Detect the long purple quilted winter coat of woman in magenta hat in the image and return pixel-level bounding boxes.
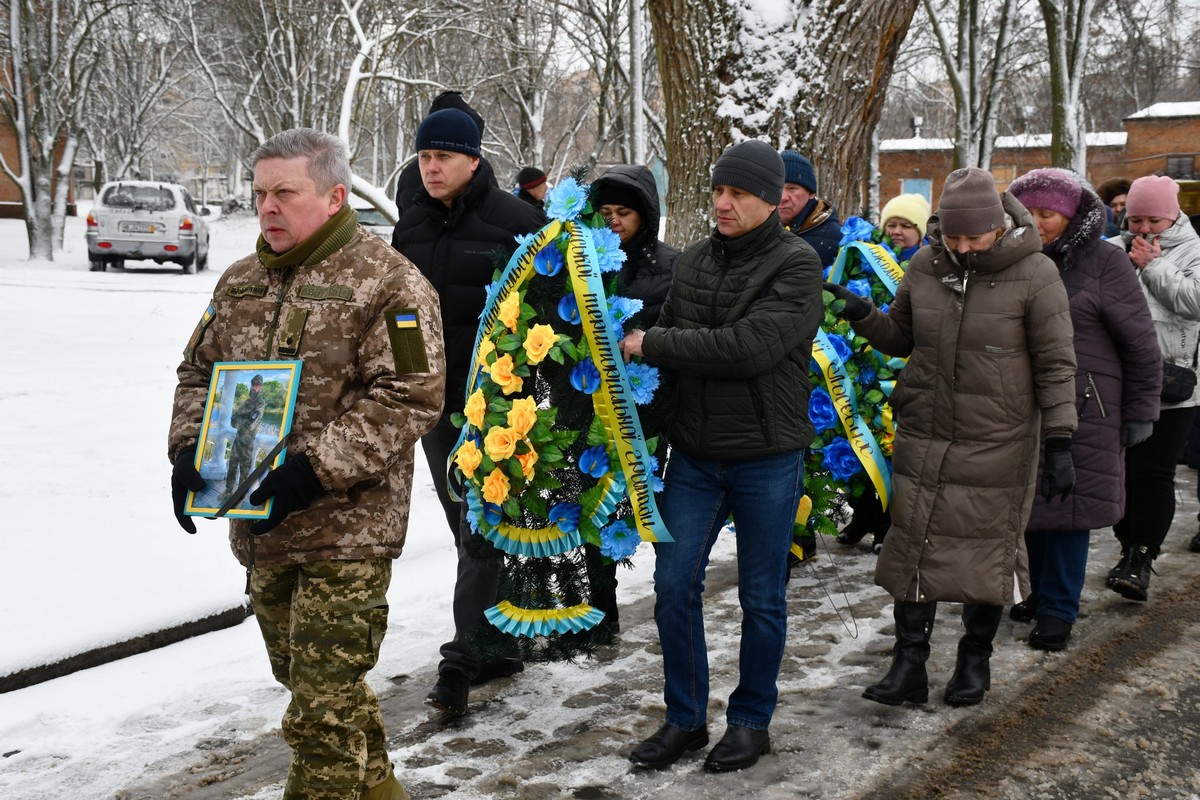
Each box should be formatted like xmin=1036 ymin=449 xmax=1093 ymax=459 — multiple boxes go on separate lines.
xmin=1028 ymin=183 xmax=1163 ymax=530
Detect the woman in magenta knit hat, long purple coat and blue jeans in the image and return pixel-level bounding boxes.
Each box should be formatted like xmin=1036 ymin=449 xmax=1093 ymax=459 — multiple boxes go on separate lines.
xmin=1008 ymin=169 xmax=1163 ymax=650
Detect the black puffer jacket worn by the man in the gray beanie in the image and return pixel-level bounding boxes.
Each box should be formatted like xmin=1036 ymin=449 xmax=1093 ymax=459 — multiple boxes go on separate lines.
xmin=642 ymin=211 xmax=822 ymax=461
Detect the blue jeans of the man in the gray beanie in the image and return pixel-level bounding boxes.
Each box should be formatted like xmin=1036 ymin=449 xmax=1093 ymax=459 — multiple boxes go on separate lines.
xmin=654 ymin=450 xmax=804 ymax=730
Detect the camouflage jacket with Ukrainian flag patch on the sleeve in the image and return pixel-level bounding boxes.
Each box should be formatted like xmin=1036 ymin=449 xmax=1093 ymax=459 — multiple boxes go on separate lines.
xmin=167 ymin=227 xmax=445 ymax=567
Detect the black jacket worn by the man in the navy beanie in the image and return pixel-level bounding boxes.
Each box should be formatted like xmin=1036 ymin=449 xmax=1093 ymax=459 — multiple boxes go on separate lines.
xmin=391 ymin=160 xmax=546 ymax=414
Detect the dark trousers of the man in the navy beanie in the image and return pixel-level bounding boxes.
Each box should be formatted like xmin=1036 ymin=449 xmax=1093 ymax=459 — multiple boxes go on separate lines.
xmin=421 ymin=415 xmax=504 ymax=678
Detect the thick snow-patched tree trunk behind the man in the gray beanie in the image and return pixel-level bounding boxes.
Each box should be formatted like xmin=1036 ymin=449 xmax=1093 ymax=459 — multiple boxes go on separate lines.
xmin=648 ymin=0 xmax=917 ymax=242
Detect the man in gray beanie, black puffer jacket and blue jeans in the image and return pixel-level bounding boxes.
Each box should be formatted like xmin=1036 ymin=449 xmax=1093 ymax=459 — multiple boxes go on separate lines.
xmin=620 ymin=142 xmax=822 ymax=772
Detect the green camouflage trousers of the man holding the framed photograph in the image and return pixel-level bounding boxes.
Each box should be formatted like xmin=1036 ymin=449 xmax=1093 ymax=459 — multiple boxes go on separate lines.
xmin=250 ymin=559 xmax=391 ymax=800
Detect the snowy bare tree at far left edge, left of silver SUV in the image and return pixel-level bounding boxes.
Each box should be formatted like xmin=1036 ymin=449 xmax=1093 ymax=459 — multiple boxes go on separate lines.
xmin=0 ymin=0 xmax=110 ymax=260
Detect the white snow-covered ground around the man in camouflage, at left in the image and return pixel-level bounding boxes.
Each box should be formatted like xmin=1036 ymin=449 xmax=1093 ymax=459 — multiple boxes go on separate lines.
xmin=0 ymin=207 xmax=650 ymax=800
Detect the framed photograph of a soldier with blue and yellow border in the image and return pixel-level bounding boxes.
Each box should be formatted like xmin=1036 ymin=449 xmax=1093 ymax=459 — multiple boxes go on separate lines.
xmin=184 ymin=361 xmax=301 ymax=519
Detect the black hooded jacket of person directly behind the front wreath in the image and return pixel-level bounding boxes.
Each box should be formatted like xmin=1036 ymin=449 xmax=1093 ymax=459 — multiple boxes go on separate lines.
xmin=592 ymin=164 xmax=679 ymax=330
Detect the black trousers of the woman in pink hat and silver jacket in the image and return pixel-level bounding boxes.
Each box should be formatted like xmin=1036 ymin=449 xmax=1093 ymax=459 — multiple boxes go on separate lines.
xmin=1112 ymin=408 xmax=1196 ymax=558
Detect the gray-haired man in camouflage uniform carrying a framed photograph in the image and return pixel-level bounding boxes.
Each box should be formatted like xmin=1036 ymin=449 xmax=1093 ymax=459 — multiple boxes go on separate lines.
xmin=168 ymin=128 xmax=444 ymax=800
